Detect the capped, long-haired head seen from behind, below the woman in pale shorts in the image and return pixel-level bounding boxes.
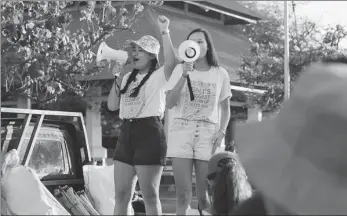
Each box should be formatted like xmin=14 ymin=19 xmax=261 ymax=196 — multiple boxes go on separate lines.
xmin=207 ymin=152 xmax=252 ymax=215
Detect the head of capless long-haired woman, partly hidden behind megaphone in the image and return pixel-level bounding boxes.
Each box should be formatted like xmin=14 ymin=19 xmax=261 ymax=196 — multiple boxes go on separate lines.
xmin=187 ymin=28 xmax=219 ymax=67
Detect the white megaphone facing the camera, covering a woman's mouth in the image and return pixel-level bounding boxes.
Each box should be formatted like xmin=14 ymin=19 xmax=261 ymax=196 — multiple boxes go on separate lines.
xmin=178 ymin=40 xmax=200 ymax=62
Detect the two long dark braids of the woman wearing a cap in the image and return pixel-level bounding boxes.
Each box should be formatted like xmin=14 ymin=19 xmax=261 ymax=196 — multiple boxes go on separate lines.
xmin=120 ymin=58 xmax=158 ymax=97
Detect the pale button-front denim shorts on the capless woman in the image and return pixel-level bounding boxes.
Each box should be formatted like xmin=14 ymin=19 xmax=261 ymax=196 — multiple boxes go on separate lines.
xmin=167 ymin=118 xmax=219 ymax=161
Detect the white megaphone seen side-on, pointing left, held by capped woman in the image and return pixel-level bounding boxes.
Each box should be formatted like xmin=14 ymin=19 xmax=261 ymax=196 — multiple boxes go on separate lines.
xmin=96 ymin=42 xmax=128 ymax=64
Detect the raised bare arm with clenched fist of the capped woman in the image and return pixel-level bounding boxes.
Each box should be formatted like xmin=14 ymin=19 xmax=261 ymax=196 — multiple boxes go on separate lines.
xmin=158 ymin=15 xmax=179 ymax=80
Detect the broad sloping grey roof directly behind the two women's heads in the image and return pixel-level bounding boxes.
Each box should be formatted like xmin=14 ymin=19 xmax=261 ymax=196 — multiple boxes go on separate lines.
xmin=79 ymin=10 xmax=250 ymax=81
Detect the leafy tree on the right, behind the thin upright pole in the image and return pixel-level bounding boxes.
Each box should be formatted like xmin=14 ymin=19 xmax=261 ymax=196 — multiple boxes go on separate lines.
xmin=237 ymin=2 xmax=347 ymax=111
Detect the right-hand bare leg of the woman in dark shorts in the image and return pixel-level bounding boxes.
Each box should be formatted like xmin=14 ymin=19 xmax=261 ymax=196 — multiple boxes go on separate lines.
xmin=135 ymin=165 xmax=164 ymax=215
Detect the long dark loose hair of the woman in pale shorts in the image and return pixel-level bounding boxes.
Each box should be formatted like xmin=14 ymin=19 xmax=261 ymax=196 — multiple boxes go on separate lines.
xmin=187 ymin=28 xmax=220 ymax=67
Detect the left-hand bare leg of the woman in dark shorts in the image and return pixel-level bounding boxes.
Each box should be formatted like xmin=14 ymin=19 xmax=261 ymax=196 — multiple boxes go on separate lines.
xmin=114 ymin=160 xmax=137 ymax=215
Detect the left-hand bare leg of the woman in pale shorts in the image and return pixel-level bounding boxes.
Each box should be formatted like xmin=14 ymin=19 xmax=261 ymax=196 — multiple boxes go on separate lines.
xmin=172 ymin=158 xmax=193 ymax=215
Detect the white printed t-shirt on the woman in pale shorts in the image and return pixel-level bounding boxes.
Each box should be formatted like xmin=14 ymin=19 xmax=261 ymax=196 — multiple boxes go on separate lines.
xmin=165 ymin=64 xmax=231 ymax=124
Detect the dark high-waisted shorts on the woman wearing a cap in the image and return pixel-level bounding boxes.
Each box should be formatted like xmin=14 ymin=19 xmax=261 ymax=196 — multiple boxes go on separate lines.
xmin=113 ymin=117 xmax=167 ymax=166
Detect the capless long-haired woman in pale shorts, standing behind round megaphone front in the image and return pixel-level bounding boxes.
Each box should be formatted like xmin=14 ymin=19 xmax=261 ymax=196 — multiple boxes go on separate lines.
xmin=165 ymin=28 xmax=231 ymax=215
